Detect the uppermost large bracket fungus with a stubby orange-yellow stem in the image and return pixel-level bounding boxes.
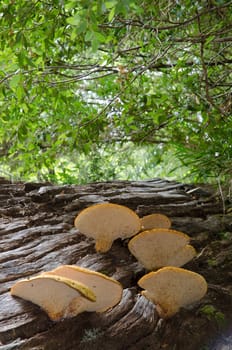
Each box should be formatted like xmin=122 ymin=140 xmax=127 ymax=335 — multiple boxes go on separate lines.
xmin=74 ymin=203 xmax=141 ymax=253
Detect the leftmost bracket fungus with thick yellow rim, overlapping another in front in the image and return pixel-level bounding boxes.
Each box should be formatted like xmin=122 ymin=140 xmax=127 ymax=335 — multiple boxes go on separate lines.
xmin=11 ymin=273 xmax=96 ymax=321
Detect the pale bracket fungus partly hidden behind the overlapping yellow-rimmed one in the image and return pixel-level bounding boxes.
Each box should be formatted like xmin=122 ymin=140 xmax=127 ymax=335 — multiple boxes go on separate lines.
xmin=44 ymin=265 xmax=123 ymax=312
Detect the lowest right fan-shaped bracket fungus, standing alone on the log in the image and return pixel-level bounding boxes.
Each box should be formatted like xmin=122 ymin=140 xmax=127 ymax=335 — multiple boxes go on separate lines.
xmin=138 ymin=266 xmax=207 ymax=318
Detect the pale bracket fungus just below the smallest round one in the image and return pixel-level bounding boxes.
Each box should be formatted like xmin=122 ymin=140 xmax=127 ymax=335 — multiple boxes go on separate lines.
xmin=128 ymin=229 xmax=196 ymax=270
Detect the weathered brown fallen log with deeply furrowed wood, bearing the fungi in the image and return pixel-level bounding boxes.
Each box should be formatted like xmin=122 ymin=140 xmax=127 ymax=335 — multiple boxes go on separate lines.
xmin=0 ymin=179 xmax=232 ymax=350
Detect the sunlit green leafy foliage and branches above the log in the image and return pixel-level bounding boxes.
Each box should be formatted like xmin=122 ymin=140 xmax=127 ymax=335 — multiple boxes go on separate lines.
xmin=0 ymin=0 xmax=232 ymax=182
